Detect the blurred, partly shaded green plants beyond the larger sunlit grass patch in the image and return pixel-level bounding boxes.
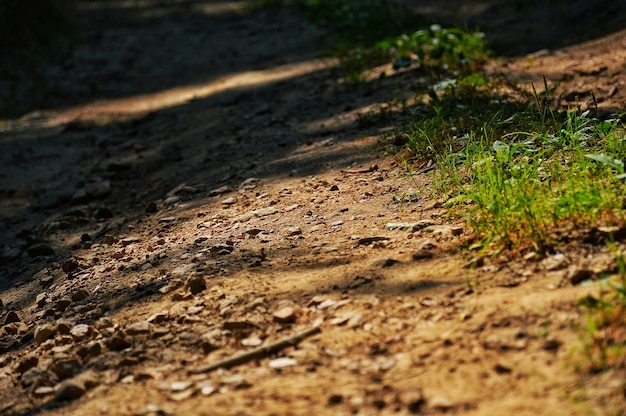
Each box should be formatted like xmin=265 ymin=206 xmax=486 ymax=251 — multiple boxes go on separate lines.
xmin=259 ymin=0 xmax=489 ymax=83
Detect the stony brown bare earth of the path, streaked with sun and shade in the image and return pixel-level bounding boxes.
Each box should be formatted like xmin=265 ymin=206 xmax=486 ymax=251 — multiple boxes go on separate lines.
xmin=0 ymin=0 xmax=626 ymax=415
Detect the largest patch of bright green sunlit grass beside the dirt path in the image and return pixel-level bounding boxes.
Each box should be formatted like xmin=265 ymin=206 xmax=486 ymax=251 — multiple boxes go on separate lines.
xmin=407 ymin=79 xmax=626 ymax=252
